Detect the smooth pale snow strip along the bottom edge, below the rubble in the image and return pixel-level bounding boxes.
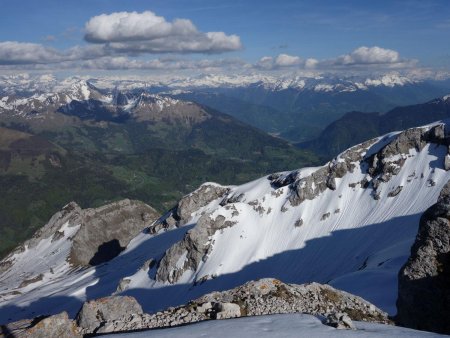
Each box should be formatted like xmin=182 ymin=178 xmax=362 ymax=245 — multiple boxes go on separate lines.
xmin=105 ymin=314 xmax=445 ymax=338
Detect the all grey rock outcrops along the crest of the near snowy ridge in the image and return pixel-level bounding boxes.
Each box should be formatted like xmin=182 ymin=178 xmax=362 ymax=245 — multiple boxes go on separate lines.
xmin=156 ymin=124 xmax=450 ymax=283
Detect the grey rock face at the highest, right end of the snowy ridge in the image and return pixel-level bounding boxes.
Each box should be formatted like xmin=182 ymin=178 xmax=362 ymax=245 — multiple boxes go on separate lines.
xmin=284 ymin=125 xmax=450 ymax=206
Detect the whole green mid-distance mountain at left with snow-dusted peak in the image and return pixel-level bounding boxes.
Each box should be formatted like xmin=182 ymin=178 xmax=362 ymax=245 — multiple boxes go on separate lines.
xmin=0 ymin=81 xmax=317 ymax=254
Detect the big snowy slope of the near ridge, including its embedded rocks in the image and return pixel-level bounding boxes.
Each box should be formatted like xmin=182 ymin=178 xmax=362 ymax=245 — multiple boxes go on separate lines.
xmin=0 ymin=124 xmax=450 ymax=322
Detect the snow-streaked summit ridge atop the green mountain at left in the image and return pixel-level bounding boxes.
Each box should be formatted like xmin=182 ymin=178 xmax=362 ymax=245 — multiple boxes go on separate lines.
xmin=0 ymin=80 xmax=210 ymax=125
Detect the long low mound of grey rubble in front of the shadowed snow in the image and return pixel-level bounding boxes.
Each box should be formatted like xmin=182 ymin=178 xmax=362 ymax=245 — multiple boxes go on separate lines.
xmin=78 ymin=279 xmax=389 ymax=333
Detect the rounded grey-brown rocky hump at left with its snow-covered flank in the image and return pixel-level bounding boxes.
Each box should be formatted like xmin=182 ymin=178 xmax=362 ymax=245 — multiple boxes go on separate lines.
xmin=0 ymin=199 xmax=158 ymax=288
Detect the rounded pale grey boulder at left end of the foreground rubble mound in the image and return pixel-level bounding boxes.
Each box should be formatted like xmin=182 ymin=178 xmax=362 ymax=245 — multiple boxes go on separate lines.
xmin=76 ymin=296 xmax=143 ymax=333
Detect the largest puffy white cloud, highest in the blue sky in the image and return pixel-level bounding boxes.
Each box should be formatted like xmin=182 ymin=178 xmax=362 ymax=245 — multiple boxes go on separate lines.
xmin=85 ymin=11 xmax=242 ymax=53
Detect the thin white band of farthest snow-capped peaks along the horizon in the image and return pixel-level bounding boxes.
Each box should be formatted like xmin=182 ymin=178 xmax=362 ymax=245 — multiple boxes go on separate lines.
xmin=0 ymin=72 xmax=419 ymax=95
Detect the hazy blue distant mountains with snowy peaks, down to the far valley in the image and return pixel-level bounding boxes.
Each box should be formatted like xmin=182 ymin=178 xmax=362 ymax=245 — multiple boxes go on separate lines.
xmin=0 ymin=73 xmax=450 ymax=142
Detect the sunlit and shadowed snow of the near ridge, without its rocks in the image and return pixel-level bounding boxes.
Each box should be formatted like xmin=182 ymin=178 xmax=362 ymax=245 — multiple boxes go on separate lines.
xmin=0 ymin=121 xmax=450 ymax=330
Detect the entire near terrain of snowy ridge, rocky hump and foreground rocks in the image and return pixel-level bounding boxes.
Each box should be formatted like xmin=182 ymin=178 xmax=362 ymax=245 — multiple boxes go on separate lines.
xmin=0 ymin=121 xmax=450 ymax=336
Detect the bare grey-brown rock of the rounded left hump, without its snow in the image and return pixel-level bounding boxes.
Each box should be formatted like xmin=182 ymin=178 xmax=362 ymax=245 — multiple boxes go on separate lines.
xmin=0 ymin=199 xmax=159 ymax=274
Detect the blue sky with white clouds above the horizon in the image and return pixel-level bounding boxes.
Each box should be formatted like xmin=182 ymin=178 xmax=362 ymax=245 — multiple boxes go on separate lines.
xmin=0 ymin=0 xmax=450 ymax=75
